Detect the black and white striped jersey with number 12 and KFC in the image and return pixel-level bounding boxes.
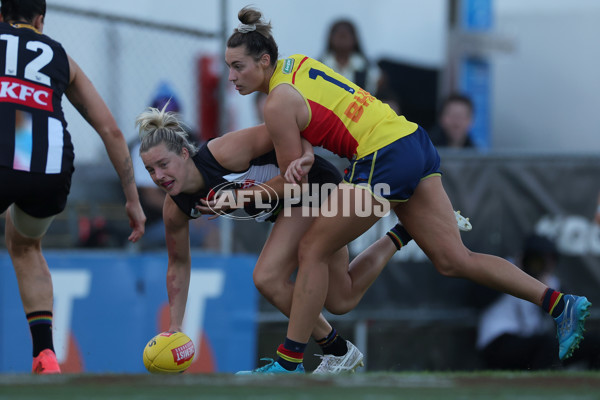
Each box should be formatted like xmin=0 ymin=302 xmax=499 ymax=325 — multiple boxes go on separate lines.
xmin=0 ymin=23 xmax=74 ymax=174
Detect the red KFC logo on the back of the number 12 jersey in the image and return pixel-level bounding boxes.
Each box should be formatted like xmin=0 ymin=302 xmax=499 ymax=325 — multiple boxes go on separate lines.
xmin=0 ymin=77 xmax=54 ymax=111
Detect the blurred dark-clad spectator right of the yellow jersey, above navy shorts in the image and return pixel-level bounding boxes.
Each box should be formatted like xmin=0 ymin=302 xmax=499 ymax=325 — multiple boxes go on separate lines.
xmin=429 ymin=94 xmax=475 ymax=149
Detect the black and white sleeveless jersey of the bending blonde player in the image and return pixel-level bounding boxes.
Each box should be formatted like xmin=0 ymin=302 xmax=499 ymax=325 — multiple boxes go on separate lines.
xmin=171 ymin=143 xmax=342 ymax=221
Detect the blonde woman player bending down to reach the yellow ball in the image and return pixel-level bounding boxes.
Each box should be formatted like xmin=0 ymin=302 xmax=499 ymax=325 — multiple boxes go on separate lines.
xmin=137 ymin=108 xmax=469 ymax=373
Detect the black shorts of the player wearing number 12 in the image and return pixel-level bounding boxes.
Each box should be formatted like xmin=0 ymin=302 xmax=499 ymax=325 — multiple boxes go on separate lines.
xmin=0 ymin=167 xmax=72 ymax=218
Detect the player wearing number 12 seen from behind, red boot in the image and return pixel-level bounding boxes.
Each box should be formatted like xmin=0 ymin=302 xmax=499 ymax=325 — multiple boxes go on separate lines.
xmin=0 ymin=0 xmax=146 ymax=374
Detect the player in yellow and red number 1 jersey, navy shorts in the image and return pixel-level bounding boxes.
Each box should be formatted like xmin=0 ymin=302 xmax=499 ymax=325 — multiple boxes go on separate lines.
xmin=225 ymin=7 xmax=591 ymax=373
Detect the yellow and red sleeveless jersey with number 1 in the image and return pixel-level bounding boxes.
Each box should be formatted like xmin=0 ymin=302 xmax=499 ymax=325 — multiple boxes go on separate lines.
xmin=269 ymin=54 xmax=418 ymax=159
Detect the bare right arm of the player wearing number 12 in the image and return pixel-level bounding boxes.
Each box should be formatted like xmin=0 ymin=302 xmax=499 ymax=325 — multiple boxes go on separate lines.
xmin=65 ymin=57 xmax=146 ymax=242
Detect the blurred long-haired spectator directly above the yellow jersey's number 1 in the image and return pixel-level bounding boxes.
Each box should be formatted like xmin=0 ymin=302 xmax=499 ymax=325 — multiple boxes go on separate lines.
xmin=319 ymin=19 xmax=380 ymax=93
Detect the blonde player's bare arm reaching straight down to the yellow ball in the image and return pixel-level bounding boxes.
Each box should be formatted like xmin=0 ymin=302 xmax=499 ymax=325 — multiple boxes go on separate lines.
xmin=163 ymin=195 xmax=192 ymax=331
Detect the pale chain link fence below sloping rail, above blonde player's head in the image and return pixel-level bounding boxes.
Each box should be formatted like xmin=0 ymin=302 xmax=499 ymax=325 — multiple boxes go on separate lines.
xmin=44 ymin=4 xmax=221 ymax=165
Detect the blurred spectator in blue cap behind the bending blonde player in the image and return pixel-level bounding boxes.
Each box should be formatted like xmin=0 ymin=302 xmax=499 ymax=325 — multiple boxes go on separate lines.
xmin=130 ymin=82 xmax=219 ymax=250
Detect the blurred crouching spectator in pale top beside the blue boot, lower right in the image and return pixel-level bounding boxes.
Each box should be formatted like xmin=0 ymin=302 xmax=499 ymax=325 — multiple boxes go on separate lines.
xmin=477 ymin=235 xmax=600 ymax=370
